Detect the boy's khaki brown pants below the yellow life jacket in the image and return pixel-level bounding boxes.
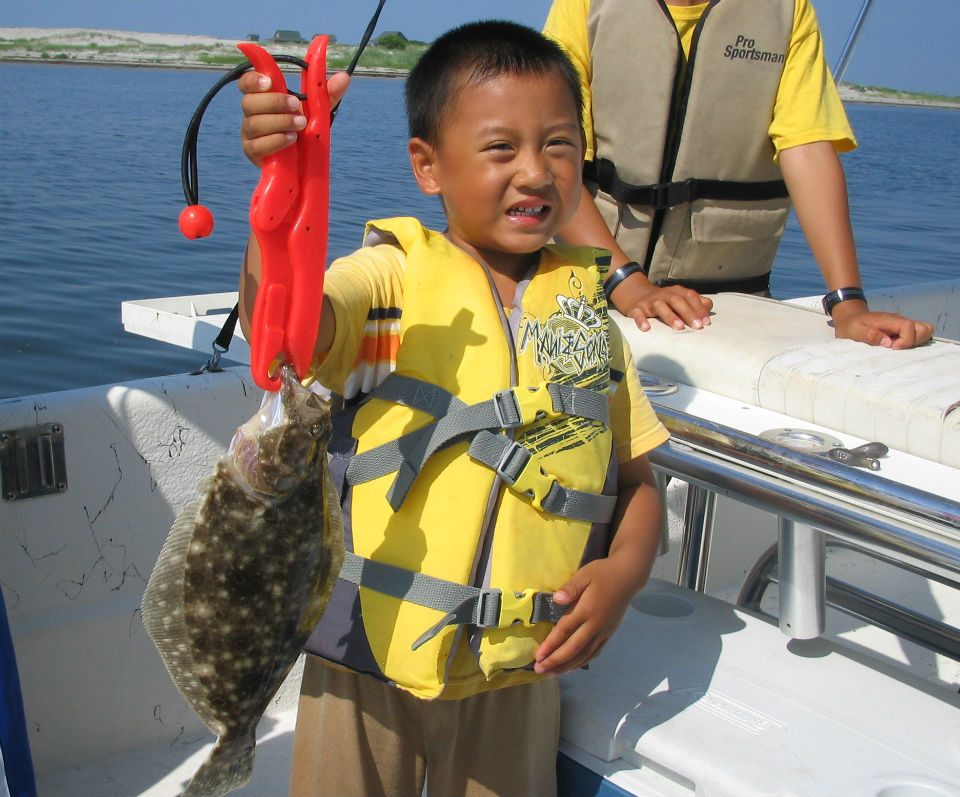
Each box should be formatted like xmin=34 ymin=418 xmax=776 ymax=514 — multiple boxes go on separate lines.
xmin=290 ymin=656 xmax=560 ymax=797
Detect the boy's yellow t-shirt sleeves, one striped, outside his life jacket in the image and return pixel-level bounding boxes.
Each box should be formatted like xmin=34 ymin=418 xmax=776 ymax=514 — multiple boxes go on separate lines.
xmin=311 ymin=236 xmax=669 ymax=462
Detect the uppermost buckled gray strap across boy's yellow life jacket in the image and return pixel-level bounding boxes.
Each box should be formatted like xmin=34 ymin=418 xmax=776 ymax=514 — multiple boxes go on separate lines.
xmin=347 ymin=377 xmax=610 ymax=511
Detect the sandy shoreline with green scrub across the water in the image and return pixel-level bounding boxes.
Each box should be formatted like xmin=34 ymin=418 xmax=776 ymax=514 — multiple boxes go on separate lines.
xmin=0 ymin=27 xmax=960 ymax=110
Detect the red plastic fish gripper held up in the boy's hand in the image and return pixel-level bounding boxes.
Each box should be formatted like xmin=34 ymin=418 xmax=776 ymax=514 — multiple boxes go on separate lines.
xmin=237 ymin=36 xmax=330 ymax=390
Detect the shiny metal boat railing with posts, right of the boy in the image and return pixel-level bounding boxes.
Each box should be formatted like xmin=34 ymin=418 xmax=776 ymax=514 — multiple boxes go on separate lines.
xmin=650 ymin=405 xmax=960 ymax=660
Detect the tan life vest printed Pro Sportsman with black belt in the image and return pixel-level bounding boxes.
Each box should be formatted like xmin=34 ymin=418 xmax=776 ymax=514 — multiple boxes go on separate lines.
xmin=586 ymin=0 xmax=794 ymax=292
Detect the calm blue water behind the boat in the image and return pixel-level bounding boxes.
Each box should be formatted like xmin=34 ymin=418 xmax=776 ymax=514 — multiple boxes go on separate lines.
xmin=0 ymin=64 xmax=960 ymax=398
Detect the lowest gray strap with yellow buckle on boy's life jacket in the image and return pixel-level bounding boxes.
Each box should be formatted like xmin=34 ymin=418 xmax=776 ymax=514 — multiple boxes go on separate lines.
xmin=340 ymin=551 xmax=568 ymax=650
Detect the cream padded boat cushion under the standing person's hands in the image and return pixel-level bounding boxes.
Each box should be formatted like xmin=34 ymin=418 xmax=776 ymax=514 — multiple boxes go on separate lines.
xmin=612 ymin=293 xmax=960 ymax=467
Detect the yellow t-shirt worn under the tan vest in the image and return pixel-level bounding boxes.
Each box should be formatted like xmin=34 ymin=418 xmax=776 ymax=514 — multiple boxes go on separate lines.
xmin=544 ymin=0 xmax=857 ymax=160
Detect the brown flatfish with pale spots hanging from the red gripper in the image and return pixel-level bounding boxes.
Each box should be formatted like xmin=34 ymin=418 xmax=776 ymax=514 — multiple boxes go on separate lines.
xmin=142 ymin=366 xmax=343 ymax=797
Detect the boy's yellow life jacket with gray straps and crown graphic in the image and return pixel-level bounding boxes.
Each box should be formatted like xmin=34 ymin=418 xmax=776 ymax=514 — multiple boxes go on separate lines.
xmin=307 ymin=218 xmax=616 ymax=698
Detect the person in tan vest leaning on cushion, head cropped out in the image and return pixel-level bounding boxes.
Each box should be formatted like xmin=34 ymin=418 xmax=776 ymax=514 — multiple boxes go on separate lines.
xmin=544 ymin=0 xmax=933 ymax=348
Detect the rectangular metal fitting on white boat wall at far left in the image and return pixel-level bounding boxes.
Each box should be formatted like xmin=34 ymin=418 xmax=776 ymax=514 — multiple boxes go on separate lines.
xmin=0 ymin=423 xmax=67 ymax=501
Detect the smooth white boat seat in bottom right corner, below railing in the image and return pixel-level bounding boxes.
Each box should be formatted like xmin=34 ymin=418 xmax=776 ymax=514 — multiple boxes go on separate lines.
xmin=560 ymin=579 xmax=960 ymax=797
